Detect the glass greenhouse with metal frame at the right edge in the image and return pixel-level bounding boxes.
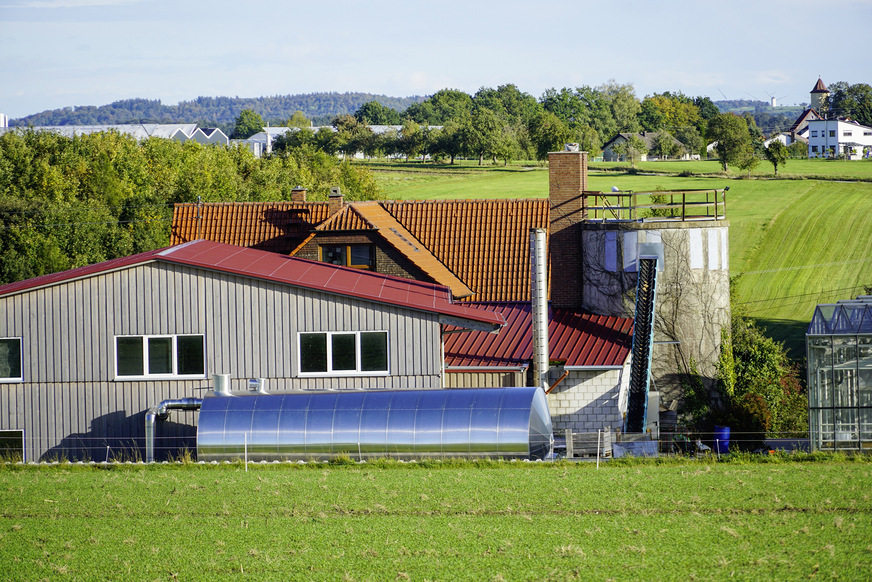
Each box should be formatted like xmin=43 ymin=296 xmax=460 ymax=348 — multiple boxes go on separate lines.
xmin=806 ymin=296 xmax=872 ymax=452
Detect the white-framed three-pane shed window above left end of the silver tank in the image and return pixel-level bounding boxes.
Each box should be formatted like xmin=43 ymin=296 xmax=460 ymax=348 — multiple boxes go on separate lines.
xmin=115 ymin=335 xmax=206 ymax=378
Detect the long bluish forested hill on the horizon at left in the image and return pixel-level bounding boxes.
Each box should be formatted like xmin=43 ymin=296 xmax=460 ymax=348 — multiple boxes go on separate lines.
xmin=9 ymin=93 xmax=425 ymax=128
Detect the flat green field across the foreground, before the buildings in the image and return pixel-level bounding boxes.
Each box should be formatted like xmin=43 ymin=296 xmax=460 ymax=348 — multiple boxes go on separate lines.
xmin=0 ymin=456 xmax=872 ymax=582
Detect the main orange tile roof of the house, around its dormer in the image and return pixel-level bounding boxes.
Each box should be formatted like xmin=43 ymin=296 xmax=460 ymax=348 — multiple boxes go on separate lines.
xmin=172 ymin=198 xmax=549 ymax=301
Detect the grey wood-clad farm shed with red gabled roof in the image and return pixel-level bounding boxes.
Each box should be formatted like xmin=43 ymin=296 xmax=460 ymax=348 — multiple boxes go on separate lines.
xmin=0 ymin=240 xmax=504 ymax=460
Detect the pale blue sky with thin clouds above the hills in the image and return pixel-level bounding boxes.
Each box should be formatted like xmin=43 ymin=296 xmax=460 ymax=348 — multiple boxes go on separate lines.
xmin=0 ymin=0 xmax=872 ymax=119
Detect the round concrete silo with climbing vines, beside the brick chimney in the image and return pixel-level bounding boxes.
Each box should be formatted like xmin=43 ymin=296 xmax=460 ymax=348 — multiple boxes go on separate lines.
xmin=581 ymin=219 xmax=730 ymax=402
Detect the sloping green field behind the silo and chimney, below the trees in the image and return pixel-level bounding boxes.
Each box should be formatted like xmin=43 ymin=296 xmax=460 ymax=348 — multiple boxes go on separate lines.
xmin=374 ymin=160 xmax=872 ymax=359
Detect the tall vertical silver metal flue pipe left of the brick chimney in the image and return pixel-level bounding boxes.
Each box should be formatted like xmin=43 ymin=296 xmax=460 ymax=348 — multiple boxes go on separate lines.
xmin=530 ymin=228 xmax=549 ymax=390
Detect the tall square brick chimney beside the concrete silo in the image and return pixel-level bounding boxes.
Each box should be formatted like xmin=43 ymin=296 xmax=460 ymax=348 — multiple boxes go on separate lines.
xmin=548 ymin=144 xmax=587 ymax=309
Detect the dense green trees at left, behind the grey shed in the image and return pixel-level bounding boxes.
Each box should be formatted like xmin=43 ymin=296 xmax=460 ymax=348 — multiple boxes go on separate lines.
xmin=0 ymin=130 xmax=379 ymax=284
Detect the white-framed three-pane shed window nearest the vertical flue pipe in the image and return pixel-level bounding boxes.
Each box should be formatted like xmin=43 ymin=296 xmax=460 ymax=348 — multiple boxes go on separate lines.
xmin=300 ymin=331 xmax=388 ymax=375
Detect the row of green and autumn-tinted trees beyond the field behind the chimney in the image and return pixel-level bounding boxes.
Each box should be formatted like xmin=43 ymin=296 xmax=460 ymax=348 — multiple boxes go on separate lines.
xmin=231 ymin=82 xmax=806 ymax=173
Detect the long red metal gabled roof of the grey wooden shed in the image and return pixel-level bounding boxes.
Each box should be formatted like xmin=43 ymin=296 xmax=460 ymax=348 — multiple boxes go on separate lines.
xmin=0 ymin=240 xmax=505 ymax=326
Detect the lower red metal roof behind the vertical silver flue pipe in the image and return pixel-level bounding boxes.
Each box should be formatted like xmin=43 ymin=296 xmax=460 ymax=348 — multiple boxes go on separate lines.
xmin=445 ymin=302 xmax=633 ymax=370
